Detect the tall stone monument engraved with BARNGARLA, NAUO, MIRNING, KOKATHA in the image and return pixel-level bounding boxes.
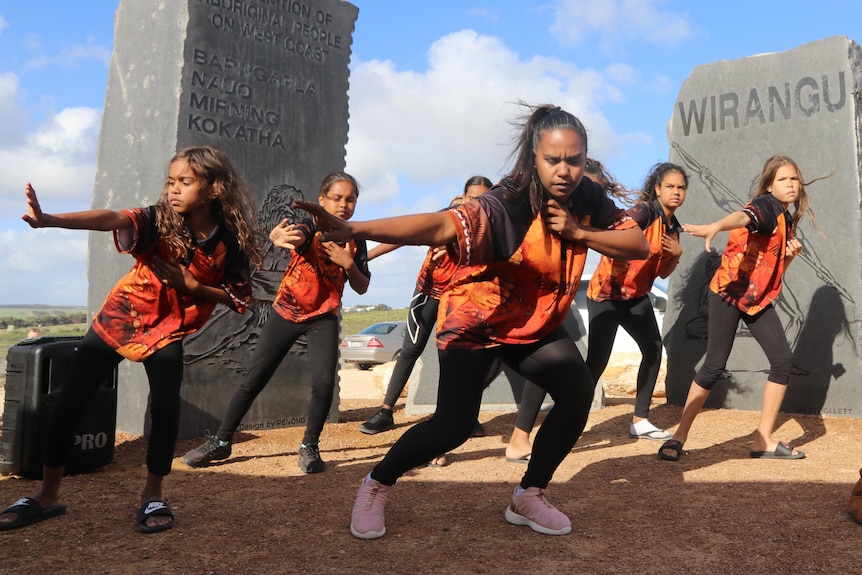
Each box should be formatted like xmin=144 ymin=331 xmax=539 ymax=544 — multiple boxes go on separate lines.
xmin=88 ymin=0 xmax=358 ymax=437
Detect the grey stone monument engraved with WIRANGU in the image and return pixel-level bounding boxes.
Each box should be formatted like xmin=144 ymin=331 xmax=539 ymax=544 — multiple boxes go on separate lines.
xmin=663 ymin=37 xmax=862 ymax=417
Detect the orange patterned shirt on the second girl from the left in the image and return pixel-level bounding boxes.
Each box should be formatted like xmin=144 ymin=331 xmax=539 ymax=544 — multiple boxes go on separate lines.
xmin=272 ymin=229 xmax=371 ymax=323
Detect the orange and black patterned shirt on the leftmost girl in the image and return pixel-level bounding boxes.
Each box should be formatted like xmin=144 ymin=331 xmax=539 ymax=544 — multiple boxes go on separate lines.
xmin=92 ymin=206 xmax=251 ymax=361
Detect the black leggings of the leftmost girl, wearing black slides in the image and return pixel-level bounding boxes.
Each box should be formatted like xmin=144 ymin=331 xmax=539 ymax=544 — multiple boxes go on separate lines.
xmin=44 ymin=329 xmax=183 ymax=476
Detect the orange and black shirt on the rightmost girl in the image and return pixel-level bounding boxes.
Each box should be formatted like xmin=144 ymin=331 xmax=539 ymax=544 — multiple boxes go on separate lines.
xmin=709 ymin=194 xmax=793 ymax=315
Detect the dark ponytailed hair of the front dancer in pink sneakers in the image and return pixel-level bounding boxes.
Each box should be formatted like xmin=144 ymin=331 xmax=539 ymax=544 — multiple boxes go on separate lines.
xmin=506 ymin=102 xmax=587 ymax=215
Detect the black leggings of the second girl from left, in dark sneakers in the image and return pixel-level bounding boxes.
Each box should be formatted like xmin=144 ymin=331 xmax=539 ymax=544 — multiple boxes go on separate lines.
xmin=216 ymin=312 xmax=338 ymax=444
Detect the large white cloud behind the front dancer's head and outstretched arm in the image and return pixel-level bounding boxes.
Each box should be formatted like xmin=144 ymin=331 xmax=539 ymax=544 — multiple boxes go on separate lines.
xmin=347 ymin=30 xmax=621 ymax=207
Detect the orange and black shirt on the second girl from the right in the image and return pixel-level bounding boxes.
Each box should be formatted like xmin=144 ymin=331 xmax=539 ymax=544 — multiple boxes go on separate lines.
xmin=587 ymin=200 xmax=680 ymax=301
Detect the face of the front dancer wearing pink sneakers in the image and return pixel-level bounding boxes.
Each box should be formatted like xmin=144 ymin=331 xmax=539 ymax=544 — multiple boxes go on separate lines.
xmin=534 ymin=128 xmax=587 ymax=205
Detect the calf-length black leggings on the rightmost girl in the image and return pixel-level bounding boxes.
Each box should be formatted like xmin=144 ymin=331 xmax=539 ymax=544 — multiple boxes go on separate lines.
xmin=694 ymin=291 xmax=793 ymax=389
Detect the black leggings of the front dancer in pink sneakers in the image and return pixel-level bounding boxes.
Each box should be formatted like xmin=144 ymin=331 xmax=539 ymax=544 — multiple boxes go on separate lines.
xmin=371 ymin=327 xmax=593 ymax=489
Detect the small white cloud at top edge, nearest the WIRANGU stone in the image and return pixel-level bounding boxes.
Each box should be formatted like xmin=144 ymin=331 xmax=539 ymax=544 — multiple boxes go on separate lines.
xmin=550 ymin=0 xmax=692 ymax=52
